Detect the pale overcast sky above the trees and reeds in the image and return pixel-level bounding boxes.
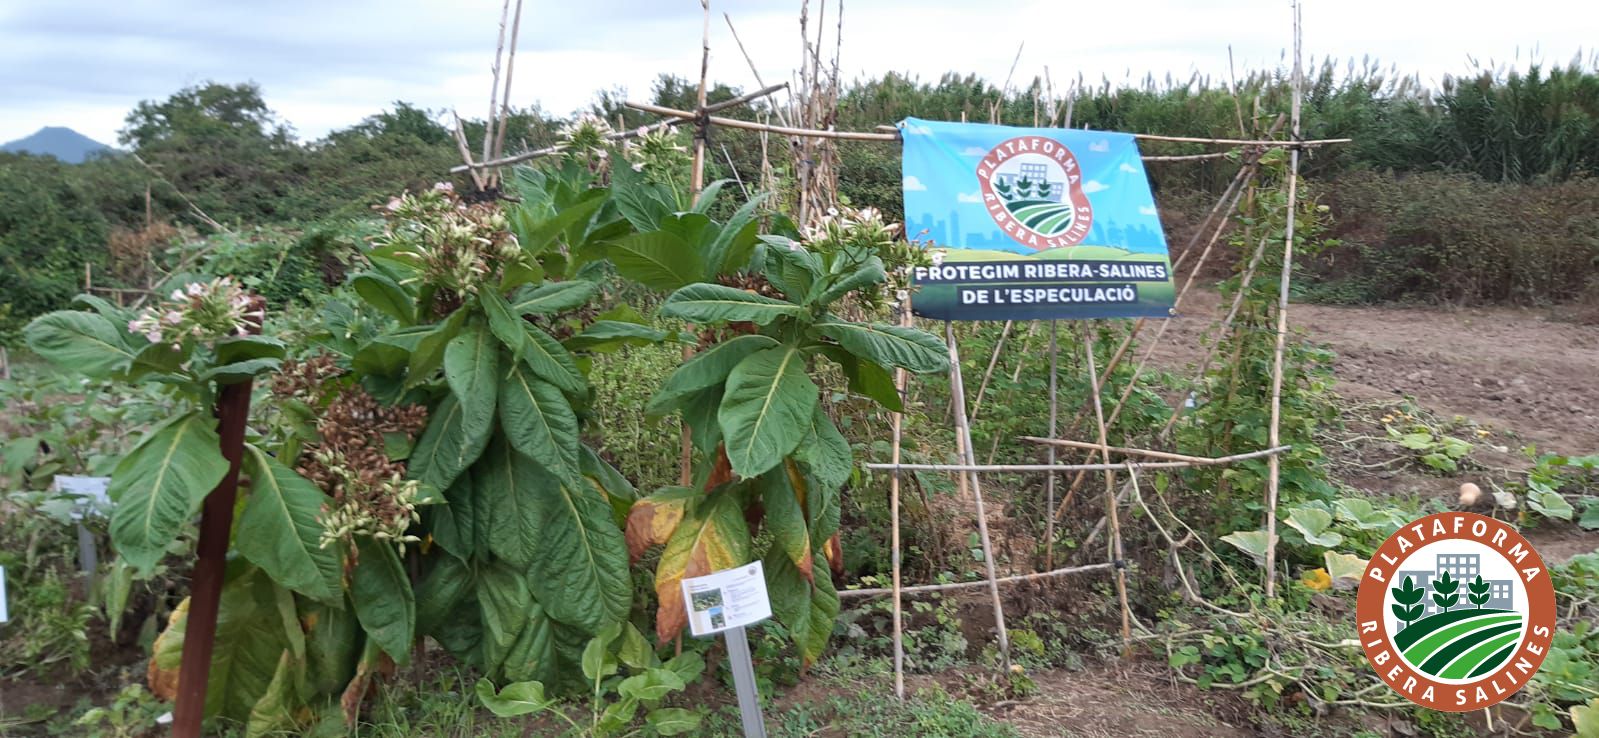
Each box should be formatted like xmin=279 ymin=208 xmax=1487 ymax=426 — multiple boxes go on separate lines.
xmin=0 ymin=0 xmax=1599 ymax=144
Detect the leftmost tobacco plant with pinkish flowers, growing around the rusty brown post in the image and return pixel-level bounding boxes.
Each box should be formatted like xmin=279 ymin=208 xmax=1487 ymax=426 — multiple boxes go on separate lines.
xmin=26 ymin=278 xmax=353 ymax=735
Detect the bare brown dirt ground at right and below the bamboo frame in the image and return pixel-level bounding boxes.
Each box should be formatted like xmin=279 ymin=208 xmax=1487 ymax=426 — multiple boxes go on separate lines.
xmin=959 ymin=286 xmax=1599 ymax=738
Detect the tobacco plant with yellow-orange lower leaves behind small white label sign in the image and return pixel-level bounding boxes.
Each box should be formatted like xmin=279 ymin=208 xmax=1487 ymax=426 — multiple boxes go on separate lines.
xmin=611 ymin=198 xmax=948 ymax=665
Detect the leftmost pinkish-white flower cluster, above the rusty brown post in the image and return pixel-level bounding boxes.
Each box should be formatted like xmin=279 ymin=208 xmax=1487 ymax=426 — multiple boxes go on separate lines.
xmin=128 ymin=276 xmax=265 ymax=351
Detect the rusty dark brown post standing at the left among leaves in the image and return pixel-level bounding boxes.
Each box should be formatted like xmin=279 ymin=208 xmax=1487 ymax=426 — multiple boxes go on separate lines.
xmin=173 ymin=380 xmax=249 ymax=738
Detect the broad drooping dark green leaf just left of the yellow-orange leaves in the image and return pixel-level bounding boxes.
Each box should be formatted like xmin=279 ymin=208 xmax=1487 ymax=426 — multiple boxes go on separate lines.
xmin=529 ymin=481 xmax=633 ymax=631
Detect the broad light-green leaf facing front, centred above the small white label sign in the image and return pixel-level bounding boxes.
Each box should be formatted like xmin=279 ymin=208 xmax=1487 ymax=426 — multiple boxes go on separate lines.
xmin=716 ymin=345 xmax=817 ymax=478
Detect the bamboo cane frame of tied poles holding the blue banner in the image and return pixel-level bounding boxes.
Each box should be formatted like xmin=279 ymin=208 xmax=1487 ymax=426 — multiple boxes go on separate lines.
xmin=451 ymin=0 xmax=1323 ymax=698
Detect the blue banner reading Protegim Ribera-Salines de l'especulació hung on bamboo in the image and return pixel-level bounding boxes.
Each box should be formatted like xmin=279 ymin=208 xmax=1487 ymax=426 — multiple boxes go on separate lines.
xmin=902 ymin=118 xmax=1174 ymax=319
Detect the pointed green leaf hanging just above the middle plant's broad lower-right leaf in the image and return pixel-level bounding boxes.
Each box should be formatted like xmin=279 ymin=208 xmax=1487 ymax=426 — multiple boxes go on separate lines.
xmin=499 ymin=363 xmax=577 ymax=479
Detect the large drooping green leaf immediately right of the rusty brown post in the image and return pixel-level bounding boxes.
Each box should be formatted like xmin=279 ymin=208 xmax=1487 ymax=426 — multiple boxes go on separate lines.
xmin=233 ymin=444 xmax=344 ymax=602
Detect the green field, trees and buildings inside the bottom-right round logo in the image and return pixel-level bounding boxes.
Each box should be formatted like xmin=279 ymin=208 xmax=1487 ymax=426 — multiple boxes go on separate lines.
xmin=1390 ymin=556 xmax=1525 ymax=679
